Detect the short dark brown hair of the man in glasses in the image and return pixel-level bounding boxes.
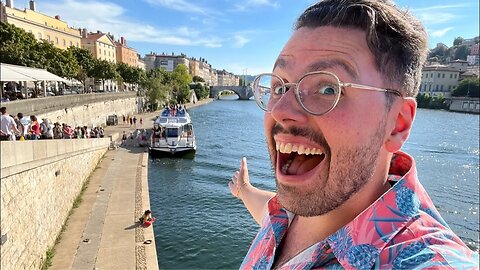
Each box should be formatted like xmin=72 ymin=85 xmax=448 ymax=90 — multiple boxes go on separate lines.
xmin=295 ymin=0 xmax=428 ymax=98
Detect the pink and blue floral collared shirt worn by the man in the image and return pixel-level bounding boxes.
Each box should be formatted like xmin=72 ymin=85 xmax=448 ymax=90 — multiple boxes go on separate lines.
xmin=241 ymin=152 xmax=479 ymax=269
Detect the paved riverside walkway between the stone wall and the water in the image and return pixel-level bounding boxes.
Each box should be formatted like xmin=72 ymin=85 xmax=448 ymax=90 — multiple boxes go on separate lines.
xmin=50 ymin=99 xmax=211 ymax=270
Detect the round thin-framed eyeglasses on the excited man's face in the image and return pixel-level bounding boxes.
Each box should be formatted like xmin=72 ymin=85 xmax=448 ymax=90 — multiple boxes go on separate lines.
xmin=252 ymin=71 xmax=403 ymax=115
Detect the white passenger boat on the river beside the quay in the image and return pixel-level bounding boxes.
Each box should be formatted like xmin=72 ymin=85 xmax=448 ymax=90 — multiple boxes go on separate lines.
xmin=149 ymin=108 xmax=196 ymax=157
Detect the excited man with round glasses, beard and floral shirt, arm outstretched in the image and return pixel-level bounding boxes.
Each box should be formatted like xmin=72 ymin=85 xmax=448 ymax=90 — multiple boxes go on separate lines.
xmin=229 ymin=0 xmax=478 ymax=269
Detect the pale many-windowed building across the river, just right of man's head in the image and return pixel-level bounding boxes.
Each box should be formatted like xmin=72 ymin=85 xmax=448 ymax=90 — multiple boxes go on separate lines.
xmin=419 ymin=65 xmax=460 ymax=97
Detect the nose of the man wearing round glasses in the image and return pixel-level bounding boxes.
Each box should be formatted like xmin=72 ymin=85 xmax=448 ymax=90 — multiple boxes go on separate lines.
xmin=270 ymin=85 xmax=307 ymax=125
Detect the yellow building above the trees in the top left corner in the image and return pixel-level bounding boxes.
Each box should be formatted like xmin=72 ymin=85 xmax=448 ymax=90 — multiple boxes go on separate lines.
xmin=0 ymin=0 xmax=81 ymax=49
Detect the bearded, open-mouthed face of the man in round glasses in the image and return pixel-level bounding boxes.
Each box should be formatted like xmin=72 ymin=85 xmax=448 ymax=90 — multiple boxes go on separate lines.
xmin=264 ymin=27 xmax=391 ymax=216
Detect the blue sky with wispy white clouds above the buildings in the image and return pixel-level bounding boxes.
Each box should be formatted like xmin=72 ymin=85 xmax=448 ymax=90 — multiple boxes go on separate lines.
xmin=32 ymin=0 xmax=479 ymax=75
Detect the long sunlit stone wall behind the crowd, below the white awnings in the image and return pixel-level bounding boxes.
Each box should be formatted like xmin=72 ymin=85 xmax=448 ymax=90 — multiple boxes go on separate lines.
xmin=1 ymin=92 xmax=144 ymax=127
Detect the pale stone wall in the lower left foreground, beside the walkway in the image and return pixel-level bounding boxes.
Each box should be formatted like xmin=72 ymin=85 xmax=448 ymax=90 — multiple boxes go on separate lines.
xmin=0 ymin=138 xmax=110 ymax=269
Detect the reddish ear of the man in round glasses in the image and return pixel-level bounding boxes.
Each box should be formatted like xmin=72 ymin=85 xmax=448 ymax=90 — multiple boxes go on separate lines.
xmin=385 ymin=97 xmax=417 ymax=153
